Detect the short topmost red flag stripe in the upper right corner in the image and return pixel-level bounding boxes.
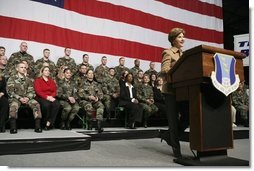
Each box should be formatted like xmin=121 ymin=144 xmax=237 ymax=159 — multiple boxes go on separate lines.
xmin=157 ymin=0 xmax=223 ymax=19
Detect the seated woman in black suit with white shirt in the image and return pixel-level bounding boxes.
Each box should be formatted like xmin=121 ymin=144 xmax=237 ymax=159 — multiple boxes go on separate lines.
xmin=119 ymin=73 xmax=143 ymax=129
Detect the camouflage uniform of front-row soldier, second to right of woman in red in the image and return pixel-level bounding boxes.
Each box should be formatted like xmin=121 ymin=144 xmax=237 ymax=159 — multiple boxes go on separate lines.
xmin=78 ymin=80 xmax=104 ymax=121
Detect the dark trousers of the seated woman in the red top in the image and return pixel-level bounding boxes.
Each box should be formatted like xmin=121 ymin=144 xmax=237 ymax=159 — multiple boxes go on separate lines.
xmin=36 ymin=97 xmax=60 ymax=125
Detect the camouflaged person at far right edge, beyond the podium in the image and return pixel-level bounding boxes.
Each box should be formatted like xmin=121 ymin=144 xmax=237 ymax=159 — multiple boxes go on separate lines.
xmin=232 ymin=82 xmax=249 ymax=127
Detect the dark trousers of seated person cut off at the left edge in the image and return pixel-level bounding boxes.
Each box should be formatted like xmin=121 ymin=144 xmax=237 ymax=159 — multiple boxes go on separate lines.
xmin=0 ymin=96 xmax=9 ymax=128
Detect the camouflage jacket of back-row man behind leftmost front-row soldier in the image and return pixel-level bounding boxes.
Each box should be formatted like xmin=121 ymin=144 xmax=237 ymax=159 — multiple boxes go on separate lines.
xmin=7 ymin=52 xmax=34 ymax=76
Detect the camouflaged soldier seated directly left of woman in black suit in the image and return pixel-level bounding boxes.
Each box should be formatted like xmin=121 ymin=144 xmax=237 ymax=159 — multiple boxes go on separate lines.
xmin=102 ymin=68 xmax=120 ymax=119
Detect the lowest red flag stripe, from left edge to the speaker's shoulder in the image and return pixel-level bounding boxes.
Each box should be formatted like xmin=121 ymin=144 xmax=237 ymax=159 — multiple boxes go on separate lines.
xmin=0 ymin=16 xmax=163 ymax=62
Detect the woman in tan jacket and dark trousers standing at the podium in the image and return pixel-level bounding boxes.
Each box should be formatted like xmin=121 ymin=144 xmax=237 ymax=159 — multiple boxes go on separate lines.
xmin=159 ymin=28 xmax=189 ymax=158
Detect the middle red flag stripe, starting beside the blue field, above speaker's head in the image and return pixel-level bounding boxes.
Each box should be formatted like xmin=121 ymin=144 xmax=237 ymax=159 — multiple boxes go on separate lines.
xmin=64 ymin=0 xmax=223 ymax=44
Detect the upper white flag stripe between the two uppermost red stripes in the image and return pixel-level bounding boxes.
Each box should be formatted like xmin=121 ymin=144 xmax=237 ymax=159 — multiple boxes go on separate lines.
xmin=98 ymin=0 xmax=223 ymax=32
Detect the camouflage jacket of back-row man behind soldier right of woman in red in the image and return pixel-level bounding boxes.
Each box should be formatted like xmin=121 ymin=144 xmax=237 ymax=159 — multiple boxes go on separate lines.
xmin=56 ymin=57 xmax=78 ymax=79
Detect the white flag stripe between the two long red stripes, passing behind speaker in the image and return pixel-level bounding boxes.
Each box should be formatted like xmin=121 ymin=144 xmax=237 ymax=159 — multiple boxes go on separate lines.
xmin=0 ymin=0 xmax=222 ymax=48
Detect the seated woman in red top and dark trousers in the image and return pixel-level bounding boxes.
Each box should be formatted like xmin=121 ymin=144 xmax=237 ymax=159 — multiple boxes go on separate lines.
xmin=34 ymin=66 xmax=60 ymax=130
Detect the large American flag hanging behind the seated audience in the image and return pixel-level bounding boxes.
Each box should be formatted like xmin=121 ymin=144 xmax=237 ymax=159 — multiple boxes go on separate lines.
xmin=0 ymin=0 xmax=223 ymax=70
